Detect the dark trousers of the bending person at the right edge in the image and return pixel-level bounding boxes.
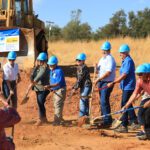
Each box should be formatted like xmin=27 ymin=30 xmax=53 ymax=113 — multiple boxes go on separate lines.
xmin=138 ymin=98 xmax=150 ymax=125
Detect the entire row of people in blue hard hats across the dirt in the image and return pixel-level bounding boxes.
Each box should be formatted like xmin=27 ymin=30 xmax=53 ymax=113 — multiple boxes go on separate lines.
xmin=0 ymin=41 xmax=150 ymax=149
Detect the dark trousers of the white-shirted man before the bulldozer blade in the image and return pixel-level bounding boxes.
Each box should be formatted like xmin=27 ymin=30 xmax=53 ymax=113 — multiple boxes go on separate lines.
xmin=2 ymin=80 xmax=18 ymax=108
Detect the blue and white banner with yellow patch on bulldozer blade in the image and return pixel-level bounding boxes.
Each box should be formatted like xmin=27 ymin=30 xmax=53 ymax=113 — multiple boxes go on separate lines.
xmin=0 ymin=29 xmax=20 ymax=52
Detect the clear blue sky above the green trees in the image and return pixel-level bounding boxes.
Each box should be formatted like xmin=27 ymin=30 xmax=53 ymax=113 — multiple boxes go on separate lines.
xmin=33 ymin=0 xmax=150 ymax=31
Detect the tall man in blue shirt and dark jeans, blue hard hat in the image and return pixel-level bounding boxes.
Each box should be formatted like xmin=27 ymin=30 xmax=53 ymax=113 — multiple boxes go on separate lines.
xmin=108 ymin=44 xmax=137 ymax=133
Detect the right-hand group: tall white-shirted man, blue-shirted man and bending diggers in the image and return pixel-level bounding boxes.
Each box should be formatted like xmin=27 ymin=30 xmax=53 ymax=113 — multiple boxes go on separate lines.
xmin=95 ymin=41 xmax=150 ymax=139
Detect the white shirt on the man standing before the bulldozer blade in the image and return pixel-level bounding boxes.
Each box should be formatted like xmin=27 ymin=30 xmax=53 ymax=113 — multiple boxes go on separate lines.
xmin=3 ymin=62 xmax=19 ymax=81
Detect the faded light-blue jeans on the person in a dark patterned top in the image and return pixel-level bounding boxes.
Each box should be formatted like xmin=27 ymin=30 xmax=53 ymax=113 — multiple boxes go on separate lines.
xmin=79 ymin=86 xmax=92 ymax=117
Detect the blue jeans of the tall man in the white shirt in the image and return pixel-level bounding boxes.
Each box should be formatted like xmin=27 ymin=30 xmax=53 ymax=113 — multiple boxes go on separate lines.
xmin=98 ymin=81 xmax=113 ymax=125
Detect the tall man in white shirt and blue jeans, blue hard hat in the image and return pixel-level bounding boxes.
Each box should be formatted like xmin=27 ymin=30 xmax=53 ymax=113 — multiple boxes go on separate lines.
xmin=95 ymin=41 xmax=116 ymax=127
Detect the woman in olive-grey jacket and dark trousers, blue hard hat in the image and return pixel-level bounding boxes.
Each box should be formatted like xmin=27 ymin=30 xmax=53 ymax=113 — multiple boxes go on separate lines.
xmin=30 ymin=52 xmax=50 ymax=126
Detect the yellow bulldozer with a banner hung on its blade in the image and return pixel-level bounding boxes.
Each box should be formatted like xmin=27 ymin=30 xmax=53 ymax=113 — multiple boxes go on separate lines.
xmin=0 ymin=0 xmax=48 ymax=67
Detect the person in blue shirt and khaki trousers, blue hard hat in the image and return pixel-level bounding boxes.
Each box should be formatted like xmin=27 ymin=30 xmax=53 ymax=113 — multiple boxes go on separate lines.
xmin=45 ymin=56 xmax=66 ymax=126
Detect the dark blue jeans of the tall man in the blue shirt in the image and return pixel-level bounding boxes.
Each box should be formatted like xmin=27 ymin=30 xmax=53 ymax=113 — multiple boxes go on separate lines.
xmin=120 ymin=90 xmax=137 ymax=127
